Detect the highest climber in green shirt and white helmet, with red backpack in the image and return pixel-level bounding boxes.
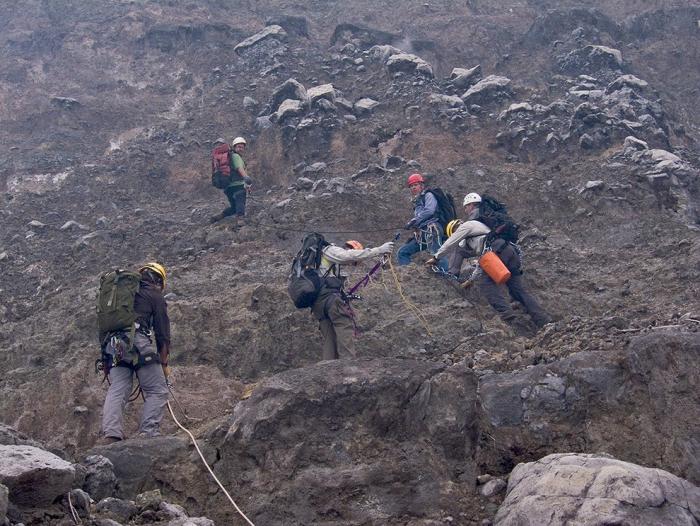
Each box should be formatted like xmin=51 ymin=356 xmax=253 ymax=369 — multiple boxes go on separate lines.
xmin=209 ymin=137 xmax=253 ymax=228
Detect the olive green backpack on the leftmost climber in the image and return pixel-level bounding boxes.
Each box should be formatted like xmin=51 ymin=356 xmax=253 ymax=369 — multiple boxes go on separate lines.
xmin=97 ymin=270 xmax=141 ymax=345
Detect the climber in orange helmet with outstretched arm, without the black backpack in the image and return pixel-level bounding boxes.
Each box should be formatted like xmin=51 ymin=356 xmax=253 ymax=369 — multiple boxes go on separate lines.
xmin=311 ymin=240 xmax=394 ymax=360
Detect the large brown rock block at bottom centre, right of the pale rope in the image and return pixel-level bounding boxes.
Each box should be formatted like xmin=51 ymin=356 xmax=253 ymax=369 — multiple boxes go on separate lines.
xmin=213 ymin=359 xmax=476 ymax=525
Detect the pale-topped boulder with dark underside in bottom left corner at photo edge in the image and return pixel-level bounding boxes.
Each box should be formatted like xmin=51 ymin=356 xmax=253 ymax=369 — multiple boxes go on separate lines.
xmin=0 ymin=446 xmax=75 ymax=507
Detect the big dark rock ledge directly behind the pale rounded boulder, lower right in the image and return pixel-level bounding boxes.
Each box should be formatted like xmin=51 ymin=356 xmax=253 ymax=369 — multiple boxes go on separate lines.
xmin=479 ymin=331 xmax=700 ymax=483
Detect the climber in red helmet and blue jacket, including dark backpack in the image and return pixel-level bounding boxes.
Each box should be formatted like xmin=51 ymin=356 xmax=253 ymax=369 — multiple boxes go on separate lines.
xmin=396 ymin=173 xmax=456 ymax=270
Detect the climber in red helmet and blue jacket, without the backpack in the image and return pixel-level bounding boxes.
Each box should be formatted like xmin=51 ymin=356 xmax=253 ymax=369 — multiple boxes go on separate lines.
xmin=396 ymin=173 xmax=446 ymax=268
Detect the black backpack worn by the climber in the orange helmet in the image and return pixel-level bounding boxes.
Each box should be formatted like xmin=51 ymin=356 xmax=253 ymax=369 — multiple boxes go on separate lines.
xmin=287 ymin=232 xmax=329 ymax=309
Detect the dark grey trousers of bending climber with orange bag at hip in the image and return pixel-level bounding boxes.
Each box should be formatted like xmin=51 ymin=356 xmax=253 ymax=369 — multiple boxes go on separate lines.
xmin=479 ymin=245 xmax=552 ymax=327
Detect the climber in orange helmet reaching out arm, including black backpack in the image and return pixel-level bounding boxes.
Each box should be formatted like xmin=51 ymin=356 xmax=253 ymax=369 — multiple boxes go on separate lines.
xmin=287 ymin=237 xmax=394 ymax=360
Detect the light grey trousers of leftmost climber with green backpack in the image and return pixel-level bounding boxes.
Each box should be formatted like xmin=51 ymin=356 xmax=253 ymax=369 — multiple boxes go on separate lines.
xmin=102 ymin=332 xmax=168 ymax=439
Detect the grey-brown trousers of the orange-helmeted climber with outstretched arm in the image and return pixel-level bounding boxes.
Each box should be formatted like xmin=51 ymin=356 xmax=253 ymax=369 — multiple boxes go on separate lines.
xmin=311 ymin=294 xmax=355 ymax=360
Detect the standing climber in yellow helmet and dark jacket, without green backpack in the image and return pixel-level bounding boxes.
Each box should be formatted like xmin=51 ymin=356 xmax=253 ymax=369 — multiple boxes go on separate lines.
xmin=102 ymin=263 xmax=170 ymax=443
